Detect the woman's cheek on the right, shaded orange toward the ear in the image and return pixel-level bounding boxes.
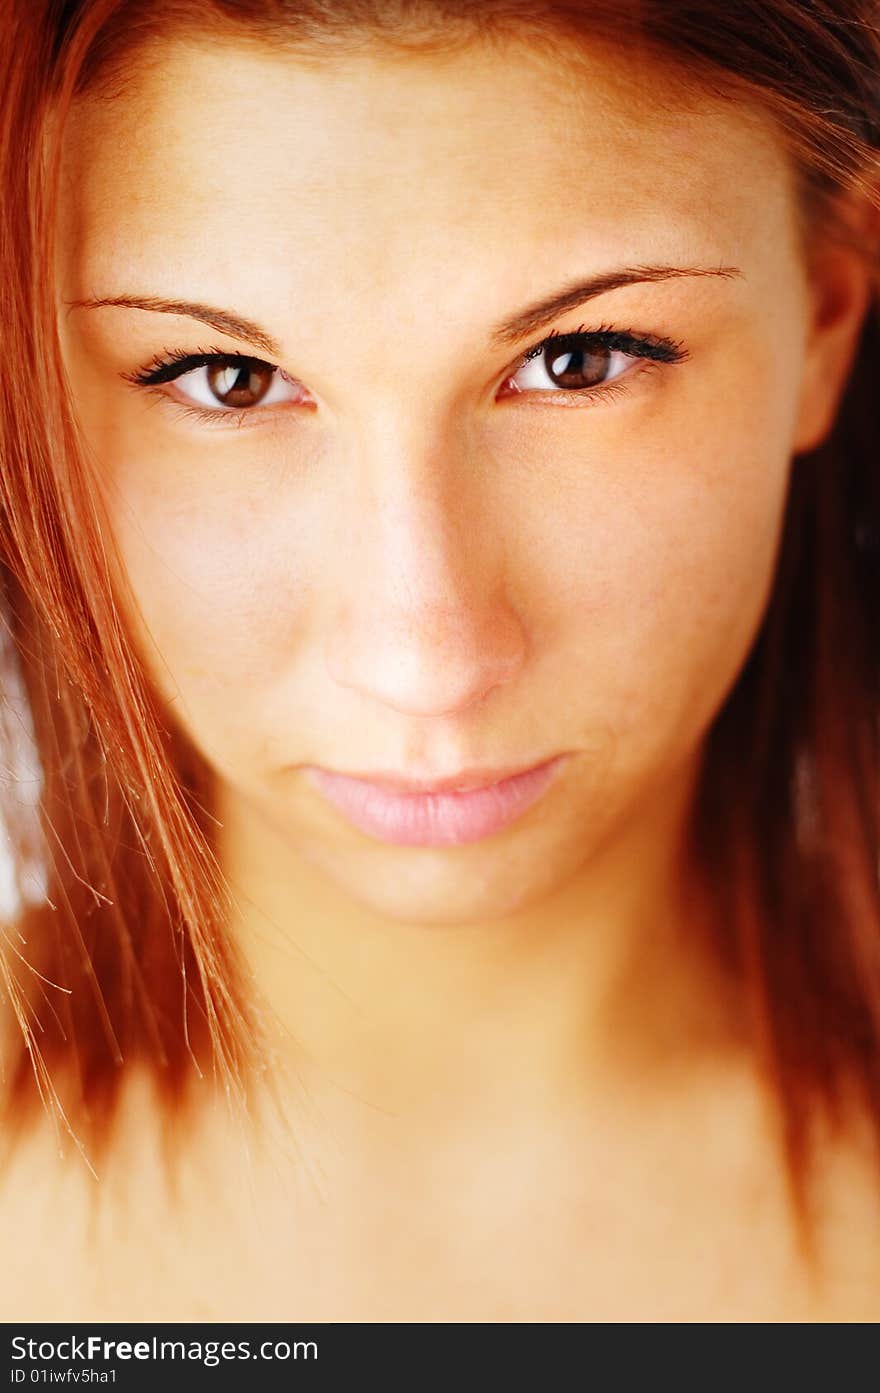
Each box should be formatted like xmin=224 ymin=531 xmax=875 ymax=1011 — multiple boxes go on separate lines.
xmin=523 ymin=373 xmax=791 ymax=772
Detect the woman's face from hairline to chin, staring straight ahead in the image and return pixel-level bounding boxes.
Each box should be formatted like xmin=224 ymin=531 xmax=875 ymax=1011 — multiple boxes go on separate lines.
xmin=60 ymin=29 xmax=868 ymax=921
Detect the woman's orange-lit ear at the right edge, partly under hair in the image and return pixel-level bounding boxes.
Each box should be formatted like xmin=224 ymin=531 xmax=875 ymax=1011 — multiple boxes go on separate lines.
xmin=794 ymin=203 xmax=880 ymax=454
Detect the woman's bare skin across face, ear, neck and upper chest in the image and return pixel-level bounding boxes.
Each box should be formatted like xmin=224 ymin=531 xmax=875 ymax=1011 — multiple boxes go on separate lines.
xmin=3 ymin=27 xmax=880 ymax=1321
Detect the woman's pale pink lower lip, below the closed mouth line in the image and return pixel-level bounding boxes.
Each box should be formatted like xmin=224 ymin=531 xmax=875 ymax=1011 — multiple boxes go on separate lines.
xmin=305 ymin=755 xmax=564 ymax=847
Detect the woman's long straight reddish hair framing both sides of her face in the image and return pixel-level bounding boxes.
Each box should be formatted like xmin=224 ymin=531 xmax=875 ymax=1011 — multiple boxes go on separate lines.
xmin=0 ymin=0 xmax=880 ymax=1264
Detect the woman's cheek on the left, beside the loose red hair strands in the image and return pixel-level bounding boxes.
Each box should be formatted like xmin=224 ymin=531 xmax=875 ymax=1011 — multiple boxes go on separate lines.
xmin=102 ymin=450 xmax=323 ymax=756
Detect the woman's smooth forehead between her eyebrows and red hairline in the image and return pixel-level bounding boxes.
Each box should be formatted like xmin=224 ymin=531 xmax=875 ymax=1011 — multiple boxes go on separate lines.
xmin=61 ymin=39 xmax=791 ymax=328
